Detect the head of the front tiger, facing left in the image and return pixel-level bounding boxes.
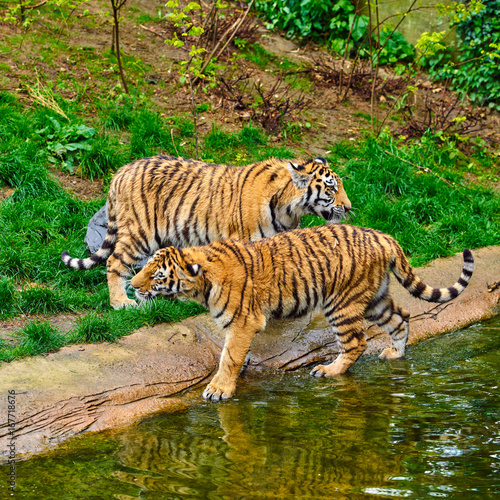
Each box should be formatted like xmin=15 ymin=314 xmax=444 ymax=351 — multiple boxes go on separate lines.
xmin=130 ymin=247 xmax=201 ymax=301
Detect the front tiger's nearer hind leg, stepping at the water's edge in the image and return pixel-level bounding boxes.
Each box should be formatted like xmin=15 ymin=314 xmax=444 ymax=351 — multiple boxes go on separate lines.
xmin=311 ymin=309 xmax=366 ymax=377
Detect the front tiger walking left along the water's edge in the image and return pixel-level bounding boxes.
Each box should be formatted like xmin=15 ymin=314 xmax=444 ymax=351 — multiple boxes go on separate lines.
xmin=131 ymin=224 xmax=474 ymax=401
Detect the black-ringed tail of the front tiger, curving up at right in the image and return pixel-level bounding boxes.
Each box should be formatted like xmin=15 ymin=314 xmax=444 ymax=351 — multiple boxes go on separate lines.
xmin=390 ymin=249 xmax=474 ymax=302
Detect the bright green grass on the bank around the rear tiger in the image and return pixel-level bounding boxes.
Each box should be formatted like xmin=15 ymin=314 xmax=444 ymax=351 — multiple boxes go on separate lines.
xmin=0 ymin=93 xmax=500 ymax=361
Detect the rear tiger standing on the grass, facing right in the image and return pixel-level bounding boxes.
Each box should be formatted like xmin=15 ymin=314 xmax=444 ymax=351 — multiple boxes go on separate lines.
xmin=61 ymin=156 xmax=351 ymax=309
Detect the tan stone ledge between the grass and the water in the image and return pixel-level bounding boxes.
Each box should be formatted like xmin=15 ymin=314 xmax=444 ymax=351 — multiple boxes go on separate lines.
xmin=0 ymin=246 xmax=500 ymax=461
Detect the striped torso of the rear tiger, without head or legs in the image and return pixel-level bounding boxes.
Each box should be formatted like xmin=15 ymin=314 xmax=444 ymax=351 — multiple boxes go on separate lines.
xmin=110 ymin=153 xmax=308 ymax=245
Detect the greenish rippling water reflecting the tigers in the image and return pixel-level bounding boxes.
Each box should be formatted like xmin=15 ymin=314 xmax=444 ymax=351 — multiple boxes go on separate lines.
xmin=0 ymin=318 xmax=500 ymax=500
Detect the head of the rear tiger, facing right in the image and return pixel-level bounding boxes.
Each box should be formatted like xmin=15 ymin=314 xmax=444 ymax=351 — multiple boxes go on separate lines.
xmin=287 ymin=156 xmax=351 ymax=223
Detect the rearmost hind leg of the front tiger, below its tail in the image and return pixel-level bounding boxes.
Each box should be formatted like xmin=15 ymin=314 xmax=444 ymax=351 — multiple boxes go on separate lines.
xmin=365 ymin=294 xmax=410 ymax=359
